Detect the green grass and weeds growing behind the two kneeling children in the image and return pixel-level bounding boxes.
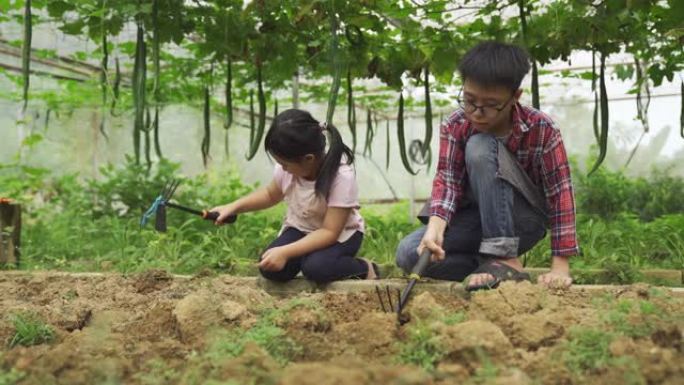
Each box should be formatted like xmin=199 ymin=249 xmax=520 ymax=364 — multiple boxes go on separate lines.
xmin=0 ymin=160 xmax=684 ymax=274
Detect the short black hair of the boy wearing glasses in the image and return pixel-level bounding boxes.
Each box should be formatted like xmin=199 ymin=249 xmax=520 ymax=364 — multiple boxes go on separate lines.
xmin=458 ymin=41 xmax=530 ymax=92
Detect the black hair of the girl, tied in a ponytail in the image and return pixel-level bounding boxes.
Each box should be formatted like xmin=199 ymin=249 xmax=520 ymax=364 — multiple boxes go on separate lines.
xmin=264 ymin=108 xmax=354 ymax=198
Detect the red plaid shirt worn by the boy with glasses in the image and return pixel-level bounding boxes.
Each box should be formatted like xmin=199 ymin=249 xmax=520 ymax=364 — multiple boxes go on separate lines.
xmin=430 ymin=104 xmax=579 ymax=256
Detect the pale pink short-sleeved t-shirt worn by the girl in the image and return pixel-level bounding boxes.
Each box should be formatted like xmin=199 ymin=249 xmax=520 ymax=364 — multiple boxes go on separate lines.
xmin=273 ymin=164 xmax=364 ymax=242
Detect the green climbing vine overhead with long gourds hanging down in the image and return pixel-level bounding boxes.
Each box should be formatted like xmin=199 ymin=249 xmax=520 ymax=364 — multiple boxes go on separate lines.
xmin=5 ymin=0 xmax=684 ymax=172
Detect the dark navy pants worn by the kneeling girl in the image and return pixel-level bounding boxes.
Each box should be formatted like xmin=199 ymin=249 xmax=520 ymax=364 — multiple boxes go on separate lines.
xmin=259 ymin=227 xmax=368 ymax=283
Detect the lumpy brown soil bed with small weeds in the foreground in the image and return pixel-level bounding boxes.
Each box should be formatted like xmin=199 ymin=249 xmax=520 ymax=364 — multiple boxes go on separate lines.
xmin=0 ymin=271 xmax=684 ymax=385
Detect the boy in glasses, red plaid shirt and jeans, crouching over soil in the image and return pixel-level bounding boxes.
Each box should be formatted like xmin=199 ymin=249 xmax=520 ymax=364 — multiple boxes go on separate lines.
xmin=397 ymin=42 xmax=579 ymax=291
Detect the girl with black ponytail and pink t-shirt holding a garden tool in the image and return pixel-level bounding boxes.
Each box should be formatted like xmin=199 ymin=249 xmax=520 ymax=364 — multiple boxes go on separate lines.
xmin=212 ymin=109 xmax=379 ymax=283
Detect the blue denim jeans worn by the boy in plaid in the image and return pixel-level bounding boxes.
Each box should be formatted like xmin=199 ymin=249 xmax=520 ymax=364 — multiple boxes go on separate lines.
xmin=396 ymin=134 xmax=547 ymax=281
